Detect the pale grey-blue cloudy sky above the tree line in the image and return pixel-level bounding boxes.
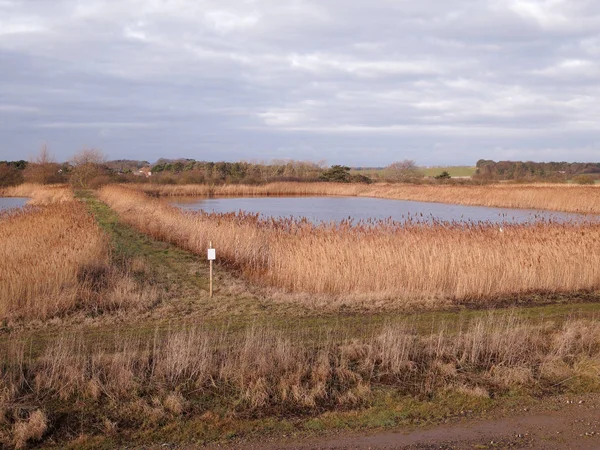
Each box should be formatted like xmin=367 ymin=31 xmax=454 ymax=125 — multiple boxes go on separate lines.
xmin=0 ymin=0 xmax=600 ymax=166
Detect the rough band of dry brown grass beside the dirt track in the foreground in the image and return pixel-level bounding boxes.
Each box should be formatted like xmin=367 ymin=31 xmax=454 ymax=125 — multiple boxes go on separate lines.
xmin=0 ymin=314 xmax=600 ymax=447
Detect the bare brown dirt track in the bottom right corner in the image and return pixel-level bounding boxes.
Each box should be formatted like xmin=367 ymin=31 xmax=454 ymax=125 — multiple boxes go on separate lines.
xmin=195 ymin=395 xmax=600 ymax=450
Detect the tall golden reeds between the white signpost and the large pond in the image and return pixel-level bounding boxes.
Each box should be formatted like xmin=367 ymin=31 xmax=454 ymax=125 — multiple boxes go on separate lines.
xmin=100 ymin=186 xmax=600 ymax=307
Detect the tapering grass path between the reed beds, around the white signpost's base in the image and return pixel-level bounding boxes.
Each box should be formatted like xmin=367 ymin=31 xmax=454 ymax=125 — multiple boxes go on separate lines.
xmin=79 ymin=192 xmax=316 ymax=322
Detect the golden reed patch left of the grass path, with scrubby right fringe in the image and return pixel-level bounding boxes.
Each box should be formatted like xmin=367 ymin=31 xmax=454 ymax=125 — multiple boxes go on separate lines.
xmin=0 ymin=200 xmax=157 ymax=320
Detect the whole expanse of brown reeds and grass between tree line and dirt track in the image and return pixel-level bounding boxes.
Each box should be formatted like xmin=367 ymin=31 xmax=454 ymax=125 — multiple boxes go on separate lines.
xmin=0 ymin=184 xmax=600 ymax=448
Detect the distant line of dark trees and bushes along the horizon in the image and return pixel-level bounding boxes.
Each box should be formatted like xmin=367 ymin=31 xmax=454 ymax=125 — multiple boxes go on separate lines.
xmin=0 ymin=146 xmax=600 ymax=188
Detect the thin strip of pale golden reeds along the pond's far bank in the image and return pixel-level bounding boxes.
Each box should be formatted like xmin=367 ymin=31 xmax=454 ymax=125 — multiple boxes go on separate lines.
xmin=134 ymin=182 xmax=600 ymax=214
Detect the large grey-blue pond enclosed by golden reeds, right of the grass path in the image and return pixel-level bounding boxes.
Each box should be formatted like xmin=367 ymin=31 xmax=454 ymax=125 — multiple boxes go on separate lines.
xmin=170 ymin=197 xmax=589 ymax=223
